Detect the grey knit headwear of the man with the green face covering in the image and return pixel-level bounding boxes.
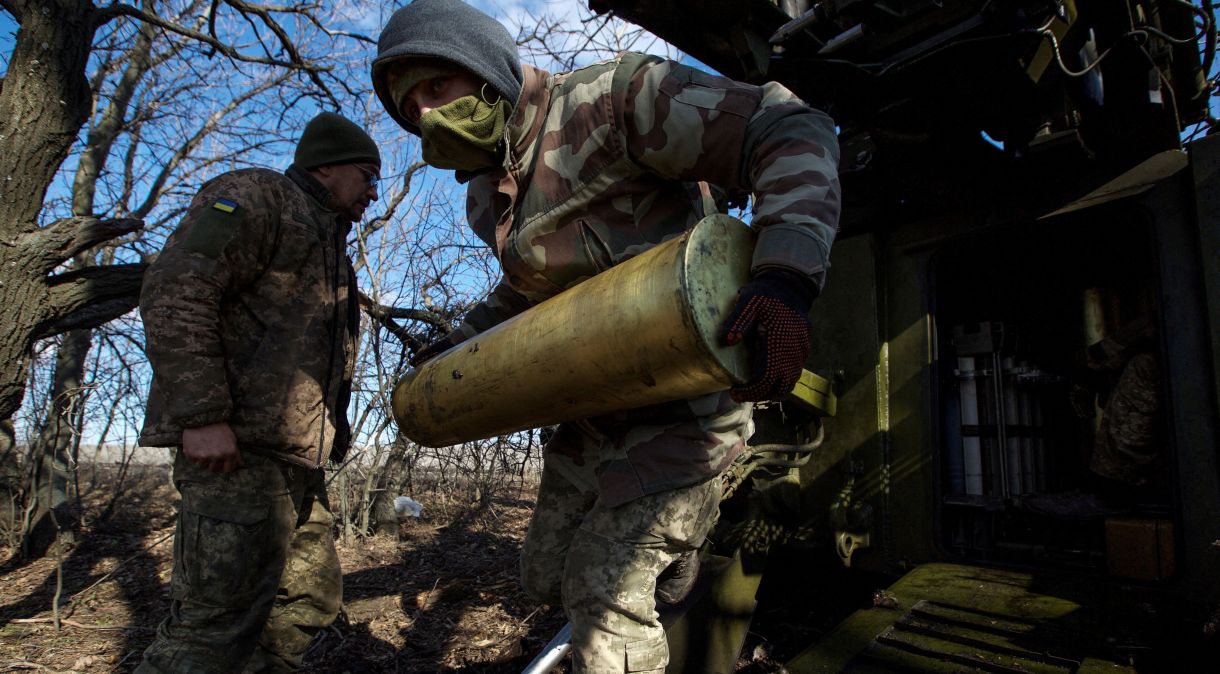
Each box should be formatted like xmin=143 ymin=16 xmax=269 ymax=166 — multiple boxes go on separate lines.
xmin=372 ymin=0 xmax=522 ymax=136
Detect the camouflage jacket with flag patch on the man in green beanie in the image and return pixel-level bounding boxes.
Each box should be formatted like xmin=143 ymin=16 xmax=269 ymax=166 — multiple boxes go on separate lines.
xmin=140 ymin=166 xmax=359 ymax=468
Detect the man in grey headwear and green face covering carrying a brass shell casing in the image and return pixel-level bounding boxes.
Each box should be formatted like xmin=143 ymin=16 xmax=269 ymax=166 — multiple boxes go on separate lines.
xmin=372 ymin=0 xmax=839 ymax=674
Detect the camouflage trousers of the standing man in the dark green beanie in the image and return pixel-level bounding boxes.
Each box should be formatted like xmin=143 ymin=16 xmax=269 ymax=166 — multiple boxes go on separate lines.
xmin=137 ymin=452 xmax=343 ymax=674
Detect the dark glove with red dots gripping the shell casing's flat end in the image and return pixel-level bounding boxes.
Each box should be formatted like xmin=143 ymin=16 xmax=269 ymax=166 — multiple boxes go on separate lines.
xmin=720 ymin=270 xmax=817 ymax=402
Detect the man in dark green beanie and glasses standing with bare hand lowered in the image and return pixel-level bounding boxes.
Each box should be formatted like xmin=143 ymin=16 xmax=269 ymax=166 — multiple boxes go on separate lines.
xmin=137 ymin=112 xmax=381 ymax=673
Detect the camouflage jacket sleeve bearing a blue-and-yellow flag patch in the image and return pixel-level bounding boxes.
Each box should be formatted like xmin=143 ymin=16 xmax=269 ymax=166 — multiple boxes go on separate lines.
xmin=140 ymin=170 xmax=278 ymax=429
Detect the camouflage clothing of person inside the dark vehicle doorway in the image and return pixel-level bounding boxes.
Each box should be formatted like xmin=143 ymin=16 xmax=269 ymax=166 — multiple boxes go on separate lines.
xmin=1089 ymin=353 xmax=1164 ymax=485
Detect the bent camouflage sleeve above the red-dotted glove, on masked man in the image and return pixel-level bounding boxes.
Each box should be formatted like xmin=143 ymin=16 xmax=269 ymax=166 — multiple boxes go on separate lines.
xmin=615 ymin=59 xmax=839 ymax=288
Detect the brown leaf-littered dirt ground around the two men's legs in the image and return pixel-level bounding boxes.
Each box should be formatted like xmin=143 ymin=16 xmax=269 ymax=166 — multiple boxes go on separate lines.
xmin=0 ymin=468 xmax=849 ymax=674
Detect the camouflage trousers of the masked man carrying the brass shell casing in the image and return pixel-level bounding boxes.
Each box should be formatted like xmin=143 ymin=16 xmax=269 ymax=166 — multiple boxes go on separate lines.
xmin=521 ymin=398 xmax=753 ymax=674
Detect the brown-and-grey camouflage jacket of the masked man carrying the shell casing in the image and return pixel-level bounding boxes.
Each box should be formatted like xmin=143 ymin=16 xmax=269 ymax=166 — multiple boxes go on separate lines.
xmin=450 ymin=54 xmax=839 ymax=502
